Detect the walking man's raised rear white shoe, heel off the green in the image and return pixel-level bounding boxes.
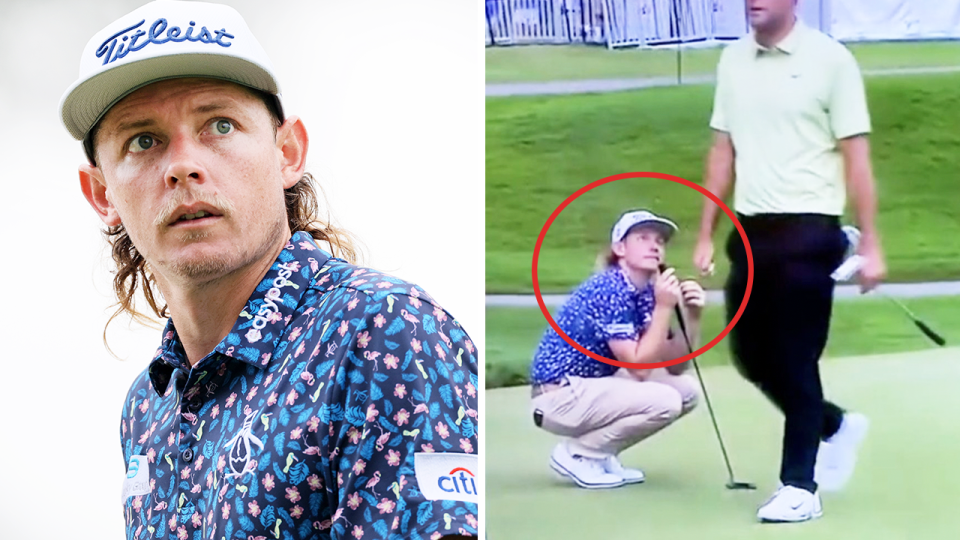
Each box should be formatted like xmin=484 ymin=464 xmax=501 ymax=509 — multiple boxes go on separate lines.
xmin=814 ymin=413 xmax=870 ymax=492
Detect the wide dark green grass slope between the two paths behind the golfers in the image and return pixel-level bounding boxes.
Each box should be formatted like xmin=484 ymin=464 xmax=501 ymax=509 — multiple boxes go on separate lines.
xmin=486 ymin=74 xmax=960 ymax=293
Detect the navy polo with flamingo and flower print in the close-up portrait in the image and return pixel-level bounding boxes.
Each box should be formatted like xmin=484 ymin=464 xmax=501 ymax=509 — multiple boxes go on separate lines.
xmin=120 ymin=233 xmax=481 ymax=540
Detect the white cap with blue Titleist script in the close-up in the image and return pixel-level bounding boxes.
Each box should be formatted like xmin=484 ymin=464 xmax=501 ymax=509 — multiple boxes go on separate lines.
xmin=60 ymin=0 xmax=282 ymax=147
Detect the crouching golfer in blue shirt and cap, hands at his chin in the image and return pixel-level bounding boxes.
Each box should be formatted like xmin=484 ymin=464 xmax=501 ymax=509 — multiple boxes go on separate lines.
xmin=531 ymin=211 xmax=705 ymax=488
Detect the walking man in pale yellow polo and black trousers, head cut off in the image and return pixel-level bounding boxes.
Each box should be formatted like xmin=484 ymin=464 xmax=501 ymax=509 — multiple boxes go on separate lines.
xmin=694 ymin=0 xmax=885 ymax=521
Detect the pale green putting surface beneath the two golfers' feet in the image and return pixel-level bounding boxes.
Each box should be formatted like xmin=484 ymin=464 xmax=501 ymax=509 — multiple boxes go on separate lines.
xmin=485 ymin=348 xmax=960 ymax=540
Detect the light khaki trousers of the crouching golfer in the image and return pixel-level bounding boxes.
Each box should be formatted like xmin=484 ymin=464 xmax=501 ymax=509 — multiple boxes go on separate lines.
xmin=531 ymin=368 xmax=699 ymax=458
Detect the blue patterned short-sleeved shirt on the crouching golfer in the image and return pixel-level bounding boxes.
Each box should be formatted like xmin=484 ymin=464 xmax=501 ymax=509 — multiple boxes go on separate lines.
xmin=530 ymin=267 xmax=654 ymax=384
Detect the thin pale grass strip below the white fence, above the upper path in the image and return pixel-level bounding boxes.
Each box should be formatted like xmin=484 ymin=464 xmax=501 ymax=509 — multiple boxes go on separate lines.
xmin=486 ymin=41 xmax=960 ymax=83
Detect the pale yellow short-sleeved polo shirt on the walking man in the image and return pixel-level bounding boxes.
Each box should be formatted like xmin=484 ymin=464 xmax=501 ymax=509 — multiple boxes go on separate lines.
xmin=710 ymin=20 xmax=870 ymax=216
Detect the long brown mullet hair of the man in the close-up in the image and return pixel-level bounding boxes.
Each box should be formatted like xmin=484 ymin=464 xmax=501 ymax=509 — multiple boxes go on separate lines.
xmin=95 ymin=87 xmax=360 ymax=353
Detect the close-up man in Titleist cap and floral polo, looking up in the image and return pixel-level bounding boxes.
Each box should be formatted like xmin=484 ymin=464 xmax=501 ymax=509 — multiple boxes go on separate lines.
xmin=60 ymin=1 xmax=481 ymax=540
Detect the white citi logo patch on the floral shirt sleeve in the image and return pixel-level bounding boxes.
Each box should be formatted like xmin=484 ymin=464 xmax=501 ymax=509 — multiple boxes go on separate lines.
xmin=413 ymin=452 xmax=482 ymax=503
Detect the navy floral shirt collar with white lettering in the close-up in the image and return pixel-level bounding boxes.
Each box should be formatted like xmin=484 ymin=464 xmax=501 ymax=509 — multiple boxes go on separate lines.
xmin=149 ymin=232 xmax=331 ymax=395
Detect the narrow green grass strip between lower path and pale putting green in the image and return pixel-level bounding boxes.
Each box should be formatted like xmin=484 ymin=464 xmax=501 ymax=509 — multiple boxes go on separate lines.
xmin=485 ymin=296 xmax=960 ymax=388
